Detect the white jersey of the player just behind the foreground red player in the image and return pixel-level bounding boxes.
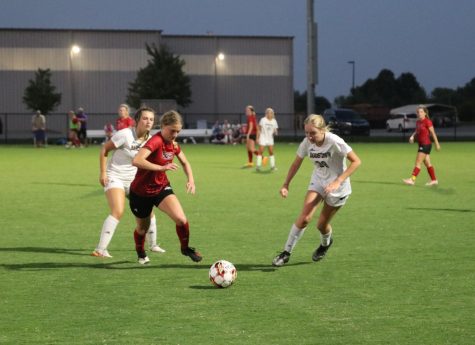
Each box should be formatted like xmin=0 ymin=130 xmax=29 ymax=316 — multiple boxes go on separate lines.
xmin=107 ymin=128 xmax=146 ymax=183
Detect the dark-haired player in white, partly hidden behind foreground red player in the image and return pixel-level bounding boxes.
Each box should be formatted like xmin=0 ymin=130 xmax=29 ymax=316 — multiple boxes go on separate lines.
xmin=91 ymin=108 xmax=165 ymax=258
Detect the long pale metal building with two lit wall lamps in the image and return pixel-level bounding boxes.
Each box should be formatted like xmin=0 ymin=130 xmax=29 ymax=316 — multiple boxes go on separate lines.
xmin=0 ymin=29 xmax=293 ymax=138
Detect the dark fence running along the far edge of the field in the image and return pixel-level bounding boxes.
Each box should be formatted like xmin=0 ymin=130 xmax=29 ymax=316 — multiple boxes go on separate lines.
xmin=0 ymin=113 xmax=475 ymax=144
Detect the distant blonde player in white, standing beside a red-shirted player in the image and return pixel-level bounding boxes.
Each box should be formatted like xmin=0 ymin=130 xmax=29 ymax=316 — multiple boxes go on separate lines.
xmin=256 ymin=108 xmax=279 ymax=171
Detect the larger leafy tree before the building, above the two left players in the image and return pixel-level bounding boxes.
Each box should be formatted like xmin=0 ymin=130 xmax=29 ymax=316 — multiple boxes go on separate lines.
xmin=127 ymin=44 xmax=192 ymax=108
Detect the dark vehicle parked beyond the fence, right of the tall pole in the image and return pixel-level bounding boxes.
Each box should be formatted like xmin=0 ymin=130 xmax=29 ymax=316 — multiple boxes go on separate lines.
xmin=323 ymin=108 xmax=370 ymax=135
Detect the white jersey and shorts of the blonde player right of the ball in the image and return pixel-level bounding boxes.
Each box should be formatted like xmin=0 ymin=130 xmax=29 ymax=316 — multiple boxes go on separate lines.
xmin=297 ymin=132 xmax=352 ymax=202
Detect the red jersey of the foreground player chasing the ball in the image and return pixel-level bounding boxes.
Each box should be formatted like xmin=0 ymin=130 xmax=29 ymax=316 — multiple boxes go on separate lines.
xmin=130 ymin=132 xmax=181 ymax=196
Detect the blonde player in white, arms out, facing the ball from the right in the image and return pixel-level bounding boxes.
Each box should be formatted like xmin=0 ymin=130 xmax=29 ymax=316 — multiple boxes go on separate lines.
xmin=272 ymin=114 xmax=361 ymax=266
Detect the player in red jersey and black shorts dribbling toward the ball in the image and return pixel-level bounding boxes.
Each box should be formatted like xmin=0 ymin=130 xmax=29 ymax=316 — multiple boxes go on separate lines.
xmin=129 ymin=110 xmax=202 ymax=264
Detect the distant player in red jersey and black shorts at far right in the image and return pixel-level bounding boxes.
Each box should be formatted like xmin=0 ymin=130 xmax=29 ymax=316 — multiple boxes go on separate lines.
xmin=403 ymin=105 xmax=440 ymax=186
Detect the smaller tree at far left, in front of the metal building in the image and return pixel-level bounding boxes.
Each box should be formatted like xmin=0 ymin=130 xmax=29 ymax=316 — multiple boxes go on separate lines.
xmin=23 ymin=68 xmax=61 ymax=114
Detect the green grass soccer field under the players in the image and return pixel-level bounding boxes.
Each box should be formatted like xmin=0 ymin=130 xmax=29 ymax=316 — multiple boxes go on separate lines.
xmin=0 ymin=142 xmax=475 ymax=345
